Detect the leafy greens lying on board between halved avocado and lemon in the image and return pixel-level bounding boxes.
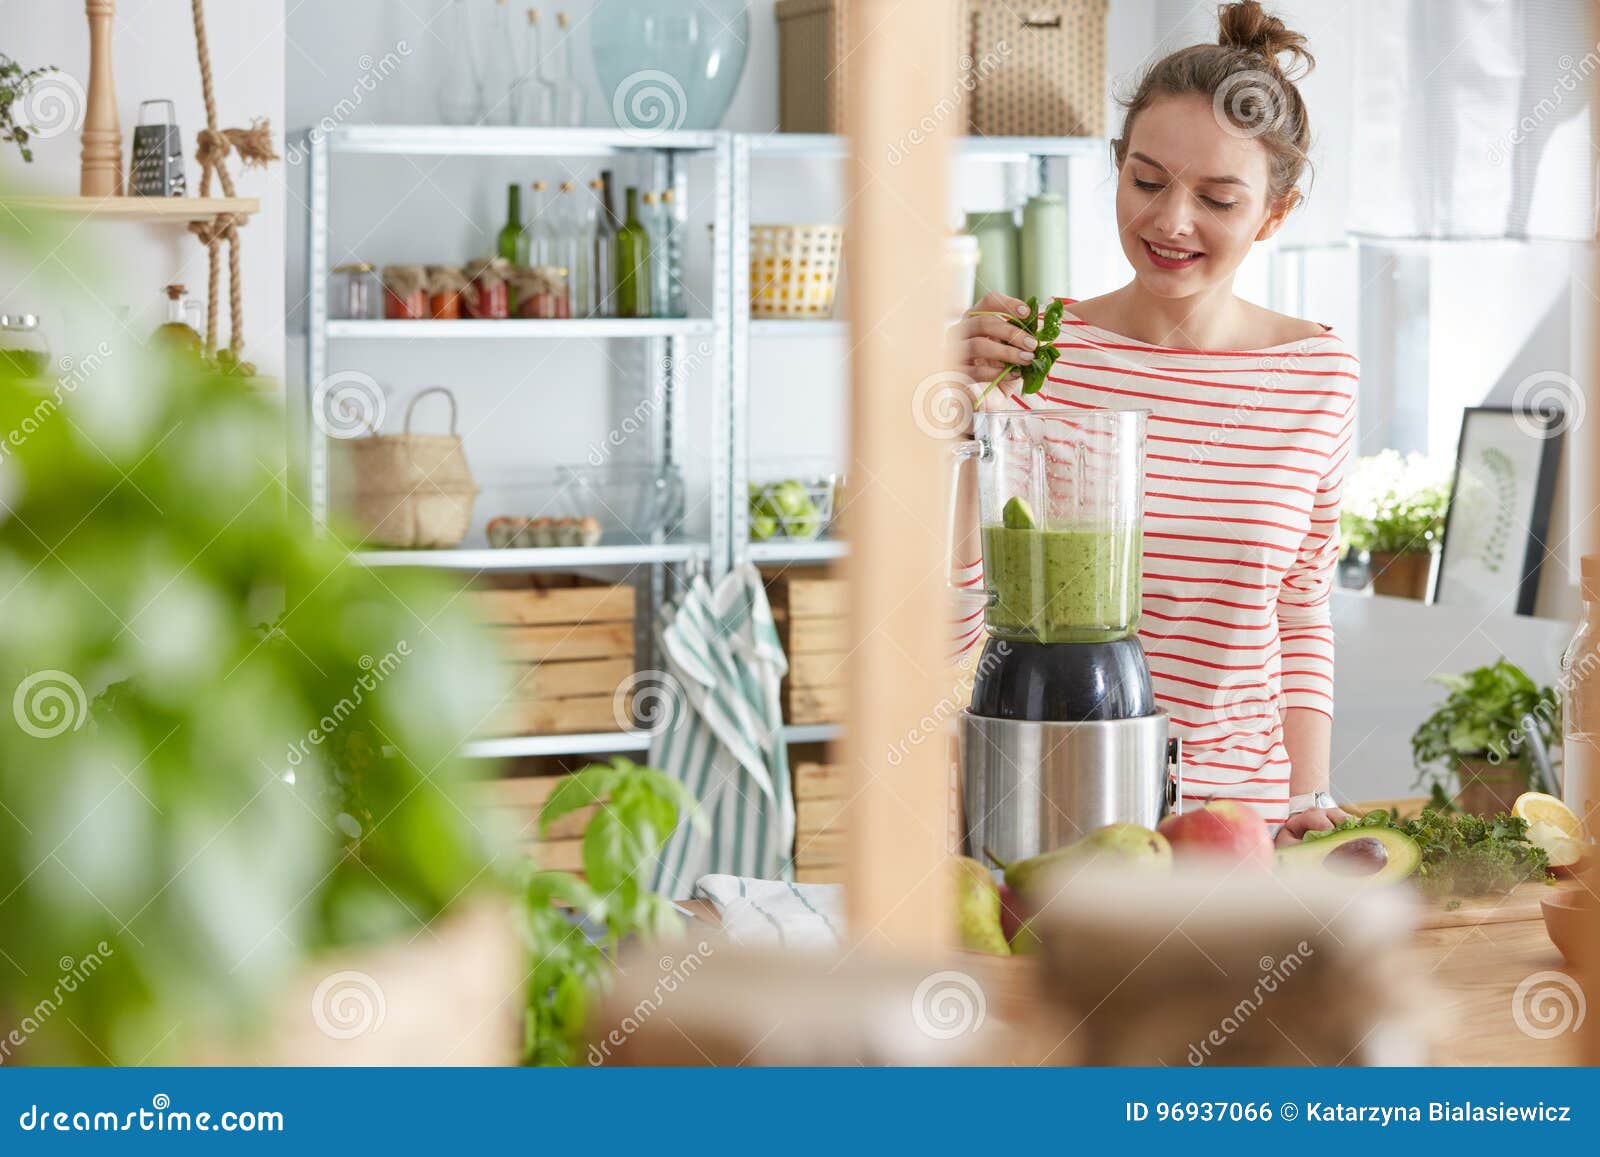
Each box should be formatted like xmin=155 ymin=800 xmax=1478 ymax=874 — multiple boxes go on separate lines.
xmin=1304 ymin=808 xmax=1550 ymax=898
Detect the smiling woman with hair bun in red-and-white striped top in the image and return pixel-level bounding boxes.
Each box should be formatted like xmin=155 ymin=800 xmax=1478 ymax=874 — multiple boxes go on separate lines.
xmin=957 ymin=0 xmax=1357 ymax=843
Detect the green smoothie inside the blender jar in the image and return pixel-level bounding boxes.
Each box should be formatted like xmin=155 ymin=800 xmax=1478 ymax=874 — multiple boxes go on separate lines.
xmin=984 ymin=523 xmax=1144 ymax=643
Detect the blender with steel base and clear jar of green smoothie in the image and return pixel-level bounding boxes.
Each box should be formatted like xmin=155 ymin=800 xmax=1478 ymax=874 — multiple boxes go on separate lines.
xmin=955 ymin=408 xmax=1182 ymax=859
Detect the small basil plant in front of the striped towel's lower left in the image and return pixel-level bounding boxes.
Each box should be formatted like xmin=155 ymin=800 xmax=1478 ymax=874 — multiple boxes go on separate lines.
xmin=522 ymin=759 xmax=707 ymax=1064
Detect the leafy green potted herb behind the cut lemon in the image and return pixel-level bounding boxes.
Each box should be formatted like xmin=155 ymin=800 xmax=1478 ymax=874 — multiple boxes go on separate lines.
xmin=1411 ymin=658 xmax=1562 ymax=779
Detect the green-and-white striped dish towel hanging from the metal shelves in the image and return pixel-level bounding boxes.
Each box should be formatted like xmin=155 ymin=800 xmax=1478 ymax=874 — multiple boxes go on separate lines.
xmin=650 ymin=565 xmax=795 ymax=898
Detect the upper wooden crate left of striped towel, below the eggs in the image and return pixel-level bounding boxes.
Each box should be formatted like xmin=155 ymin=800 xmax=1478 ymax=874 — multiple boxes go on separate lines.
xmin=466 ymin=574 xmax=635 ymax=735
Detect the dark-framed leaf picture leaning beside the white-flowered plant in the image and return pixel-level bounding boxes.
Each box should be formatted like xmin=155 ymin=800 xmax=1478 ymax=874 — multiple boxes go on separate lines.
xmin=1434 ymin=406 xmax=1566 ymax=615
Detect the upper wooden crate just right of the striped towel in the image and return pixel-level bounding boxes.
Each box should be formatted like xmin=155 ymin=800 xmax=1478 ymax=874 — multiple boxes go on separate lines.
xmin=766 ymin=568 xmax=850 ymax=723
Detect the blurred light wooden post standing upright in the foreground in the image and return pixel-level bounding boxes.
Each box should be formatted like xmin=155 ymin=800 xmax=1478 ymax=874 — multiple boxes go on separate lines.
xmin=845 ymin=0 xmax=962 ymax=957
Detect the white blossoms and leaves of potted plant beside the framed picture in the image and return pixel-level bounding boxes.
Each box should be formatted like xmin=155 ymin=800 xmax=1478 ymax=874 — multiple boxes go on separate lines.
xmin=1339 ymin=450 xmax=1450 ymax=554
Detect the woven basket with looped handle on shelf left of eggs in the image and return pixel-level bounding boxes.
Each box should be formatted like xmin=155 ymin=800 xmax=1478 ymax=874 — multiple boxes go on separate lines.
xmin=342 ymin=386 xmax=478 ymax=547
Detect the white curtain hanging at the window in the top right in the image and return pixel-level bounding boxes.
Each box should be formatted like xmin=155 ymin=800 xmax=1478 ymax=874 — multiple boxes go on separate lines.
xmin=1350 ymin=0 xmax=1600 ymax=240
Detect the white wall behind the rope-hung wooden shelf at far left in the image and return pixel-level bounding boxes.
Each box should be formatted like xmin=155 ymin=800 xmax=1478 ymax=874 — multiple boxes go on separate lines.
xmin=0 ymin=0 xmax=285 ymax=378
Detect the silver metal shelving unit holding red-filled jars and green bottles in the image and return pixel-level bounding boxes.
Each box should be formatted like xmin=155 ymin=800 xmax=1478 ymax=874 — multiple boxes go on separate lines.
xmin=298 ymin=125 xmax=733 ymax=759
